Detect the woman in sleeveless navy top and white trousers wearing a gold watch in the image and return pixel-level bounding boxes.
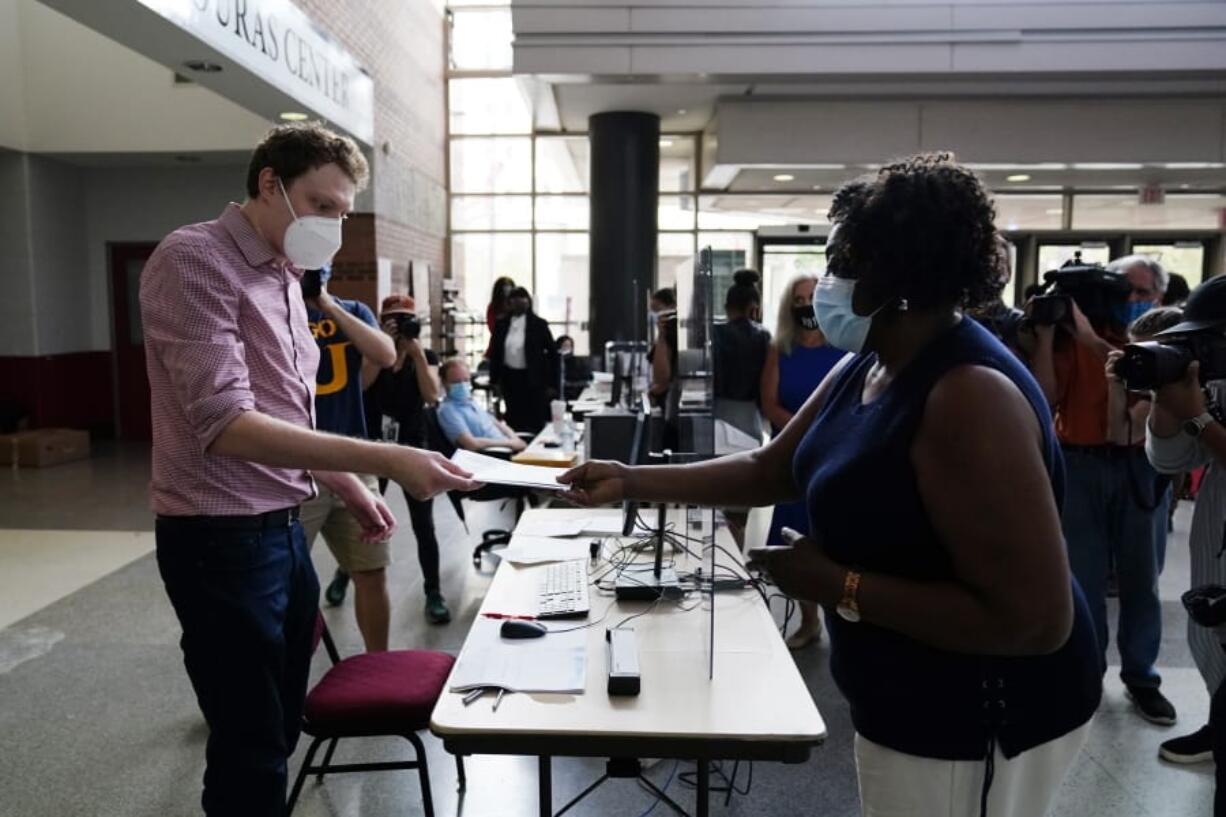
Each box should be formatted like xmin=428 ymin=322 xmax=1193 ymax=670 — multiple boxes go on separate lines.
xmin=562 ymin=155 xmax=1103 ymax=817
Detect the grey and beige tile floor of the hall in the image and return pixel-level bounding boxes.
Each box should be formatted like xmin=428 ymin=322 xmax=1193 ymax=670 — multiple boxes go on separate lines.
xmin=0 ymin=445 xmax=1213 ymax=817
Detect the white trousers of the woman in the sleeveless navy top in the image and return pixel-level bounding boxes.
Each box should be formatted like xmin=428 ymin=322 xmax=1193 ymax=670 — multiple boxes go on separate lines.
xmin=856 ymin=724 xmax=1090 ymax=817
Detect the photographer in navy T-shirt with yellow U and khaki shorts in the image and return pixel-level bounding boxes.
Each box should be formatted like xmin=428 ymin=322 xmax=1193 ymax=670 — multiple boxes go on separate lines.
xmin=302 ymin=266 xmax=396 ymax=653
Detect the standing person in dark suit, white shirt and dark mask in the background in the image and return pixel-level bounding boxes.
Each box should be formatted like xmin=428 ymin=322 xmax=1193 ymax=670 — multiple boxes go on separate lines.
xmin=489 ymin=287 xmax=558 ymax=434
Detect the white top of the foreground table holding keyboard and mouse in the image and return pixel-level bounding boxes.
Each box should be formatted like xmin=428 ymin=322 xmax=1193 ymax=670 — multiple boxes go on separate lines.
xmin=430 ymin=509 xmax=826 ymax=757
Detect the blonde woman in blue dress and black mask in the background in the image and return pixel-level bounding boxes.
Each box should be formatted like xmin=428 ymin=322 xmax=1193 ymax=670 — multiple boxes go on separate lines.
xmin=761 ymin=274 xmax=846 ymax=650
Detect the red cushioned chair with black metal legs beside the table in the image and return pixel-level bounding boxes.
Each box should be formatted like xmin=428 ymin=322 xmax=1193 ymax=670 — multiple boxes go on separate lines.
xmin=286 ymin=616 xmax=466 ymax=817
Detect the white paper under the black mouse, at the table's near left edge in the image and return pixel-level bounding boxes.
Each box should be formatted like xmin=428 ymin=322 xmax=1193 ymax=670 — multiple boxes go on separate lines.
xmin=451 ymin=618 xmax=587 ymax=694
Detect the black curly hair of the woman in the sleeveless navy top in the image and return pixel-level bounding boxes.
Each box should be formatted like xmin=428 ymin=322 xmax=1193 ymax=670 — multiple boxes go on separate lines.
xmin=826 ymin=153 xmax=1004 ymax=309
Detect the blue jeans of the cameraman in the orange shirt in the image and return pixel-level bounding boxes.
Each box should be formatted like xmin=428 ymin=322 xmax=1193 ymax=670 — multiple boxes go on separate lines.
xmin=1062 ymin=449 xmax=1170 ymax=688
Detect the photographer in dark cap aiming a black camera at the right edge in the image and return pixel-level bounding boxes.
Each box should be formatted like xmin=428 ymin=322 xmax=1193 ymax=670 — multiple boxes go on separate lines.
xmin=1116 ymin=273 xmax=1226 ymax=775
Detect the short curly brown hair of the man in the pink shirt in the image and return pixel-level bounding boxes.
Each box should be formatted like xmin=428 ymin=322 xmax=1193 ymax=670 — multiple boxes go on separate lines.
xmin=246 ymin=121 xmax=370 ymax=199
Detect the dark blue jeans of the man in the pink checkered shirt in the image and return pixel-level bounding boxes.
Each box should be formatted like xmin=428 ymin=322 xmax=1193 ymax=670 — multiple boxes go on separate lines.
xmin=157 ymin=518 xmax=319 ymax=817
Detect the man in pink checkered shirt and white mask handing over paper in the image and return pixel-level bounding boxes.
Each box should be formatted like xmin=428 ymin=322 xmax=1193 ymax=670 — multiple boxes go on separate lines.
xmin=141 ymin=124 xmax=474 ymax=816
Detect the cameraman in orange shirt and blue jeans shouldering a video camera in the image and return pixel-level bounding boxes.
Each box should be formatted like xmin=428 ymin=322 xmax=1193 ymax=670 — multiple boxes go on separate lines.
xmin=1026 ymin=255 xmax=1176 ymax=726
